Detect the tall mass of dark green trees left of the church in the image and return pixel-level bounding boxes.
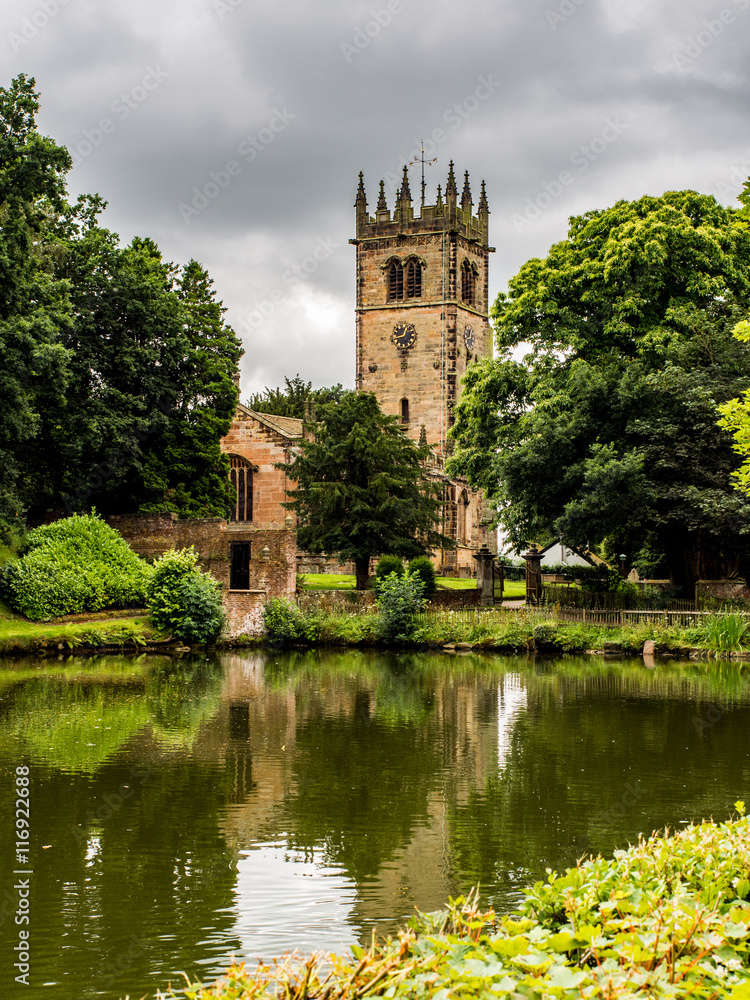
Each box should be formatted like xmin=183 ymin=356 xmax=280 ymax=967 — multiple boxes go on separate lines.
xmin=0 ymin=76 xmax=241 ymax=524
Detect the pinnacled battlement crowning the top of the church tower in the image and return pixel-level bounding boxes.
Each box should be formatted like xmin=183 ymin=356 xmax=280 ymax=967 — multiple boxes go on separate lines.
xmin=352 ymin=160 xmax=490 ymax=249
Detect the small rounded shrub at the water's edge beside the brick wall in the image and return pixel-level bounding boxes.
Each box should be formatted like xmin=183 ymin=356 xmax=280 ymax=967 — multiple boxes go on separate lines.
xmin=148 ymin=546 xmax=226 ymax=643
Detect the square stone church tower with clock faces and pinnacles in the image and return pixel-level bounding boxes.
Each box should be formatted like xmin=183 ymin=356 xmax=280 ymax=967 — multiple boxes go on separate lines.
xmin=350 ymin=161 xmax=494 ymax=461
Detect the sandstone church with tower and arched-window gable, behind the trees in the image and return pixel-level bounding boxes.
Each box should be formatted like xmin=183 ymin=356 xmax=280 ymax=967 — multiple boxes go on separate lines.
xmin=110 ymin=163 xmax=495 ymax=632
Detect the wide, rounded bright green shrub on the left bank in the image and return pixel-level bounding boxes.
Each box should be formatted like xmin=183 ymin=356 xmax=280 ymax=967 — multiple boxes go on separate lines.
xmin=0 ymin=514 xmax=152 ymax=621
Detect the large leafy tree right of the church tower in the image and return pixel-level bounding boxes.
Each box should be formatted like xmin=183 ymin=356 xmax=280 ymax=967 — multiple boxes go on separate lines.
xmin=453 ymin=191 xmax=750 ymax=586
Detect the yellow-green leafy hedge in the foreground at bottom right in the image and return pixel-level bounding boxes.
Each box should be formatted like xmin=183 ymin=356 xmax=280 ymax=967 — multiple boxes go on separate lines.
xmin=167 ymin=803 xmax=750 ymax=1000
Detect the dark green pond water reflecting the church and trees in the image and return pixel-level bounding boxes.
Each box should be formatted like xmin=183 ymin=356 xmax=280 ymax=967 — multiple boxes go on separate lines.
xmin=0 ymin=651 xmax=750 ymax=1000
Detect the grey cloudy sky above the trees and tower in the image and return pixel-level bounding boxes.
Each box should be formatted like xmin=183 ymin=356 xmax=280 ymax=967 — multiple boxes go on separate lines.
xmin=0 ymin=0 xmax=750 ymax=398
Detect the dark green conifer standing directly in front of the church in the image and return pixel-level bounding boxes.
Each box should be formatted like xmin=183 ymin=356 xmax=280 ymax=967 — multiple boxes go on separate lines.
xmin=280 ymin=392 xmax=446 ymax=590
